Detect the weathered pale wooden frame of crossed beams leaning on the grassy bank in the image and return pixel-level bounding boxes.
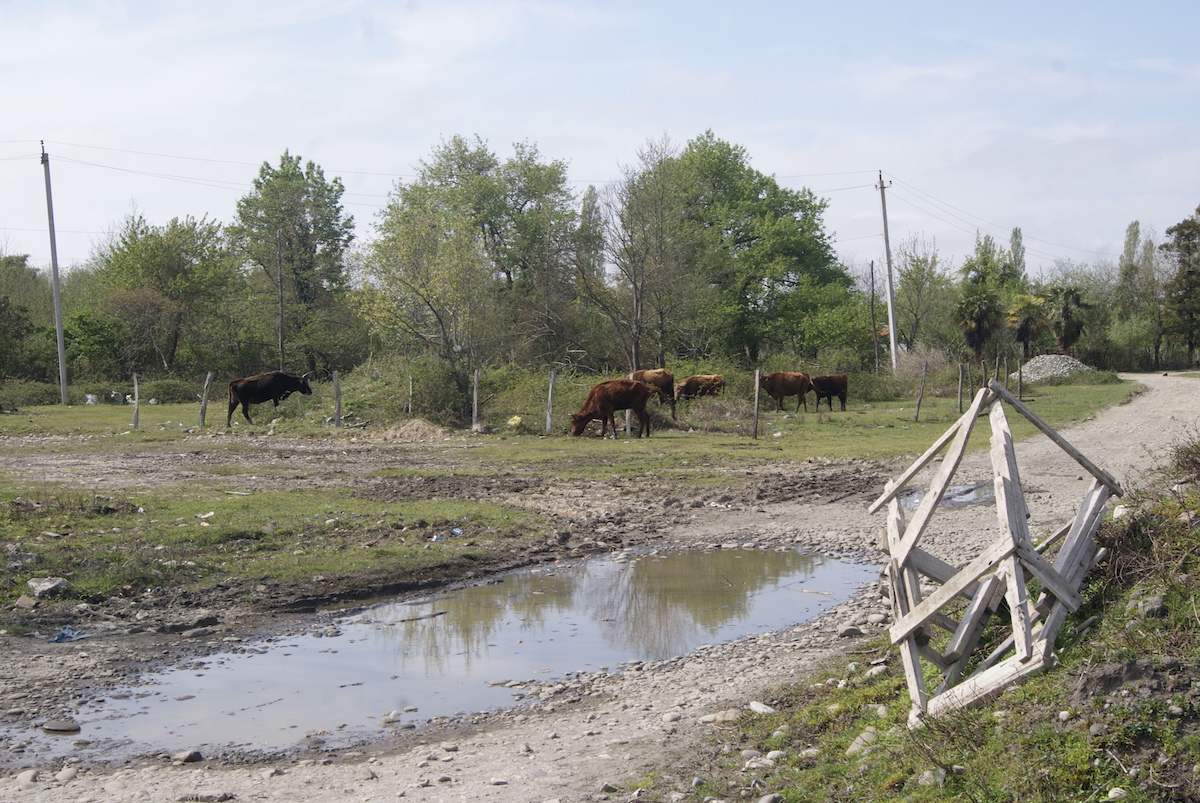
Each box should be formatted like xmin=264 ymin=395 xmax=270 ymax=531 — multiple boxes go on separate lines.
xmin=869 ymin=380 xmax=1124 ymax=725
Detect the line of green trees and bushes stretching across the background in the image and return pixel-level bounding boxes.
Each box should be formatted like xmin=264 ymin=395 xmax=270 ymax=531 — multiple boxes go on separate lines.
xmin=0 ymin=131 xmax=1200 ymax=420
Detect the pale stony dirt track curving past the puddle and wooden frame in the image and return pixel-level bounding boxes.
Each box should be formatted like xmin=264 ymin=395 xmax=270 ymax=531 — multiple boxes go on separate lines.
xmin=9 ymin=376 xmax=1200 ymax=803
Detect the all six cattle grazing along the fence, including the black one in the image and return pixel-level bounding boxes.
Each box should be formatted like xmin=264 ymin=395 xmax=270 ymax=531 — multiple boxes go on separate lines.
xmin=226 ymin=368 xmax=846 ymax=437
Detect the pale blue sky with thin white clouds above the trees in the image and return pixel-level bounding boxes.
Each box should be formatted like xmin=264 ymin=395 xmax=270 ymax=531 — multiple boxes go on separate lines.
xmin=0 ymin=0 xmax=1200 ymax=276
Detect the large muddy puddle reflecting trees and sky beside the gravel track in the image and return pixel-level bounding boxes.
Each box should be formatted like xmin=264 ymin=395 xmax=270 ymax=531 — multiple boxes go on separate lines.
xmin=14 ymin=550 xmax=876 ymax=761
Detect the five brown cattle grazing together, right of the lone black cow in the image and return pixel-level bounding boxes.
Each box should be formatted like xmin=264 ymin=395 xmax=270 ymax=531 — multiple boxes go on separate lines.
xmin=570 ymin=368 xmax=846 ymax=437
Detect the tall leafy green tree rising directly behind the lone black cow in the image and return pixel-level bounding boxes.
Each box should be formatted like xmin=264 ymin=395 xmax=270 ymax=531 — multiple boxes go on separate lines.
xmin=229 ymin=150 xmax=354 ymax=371
